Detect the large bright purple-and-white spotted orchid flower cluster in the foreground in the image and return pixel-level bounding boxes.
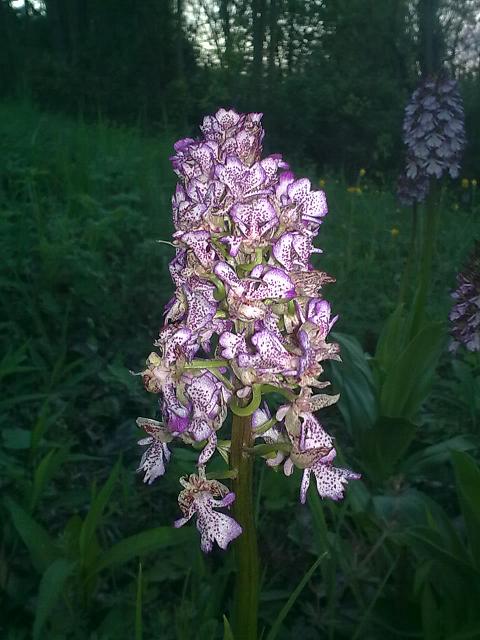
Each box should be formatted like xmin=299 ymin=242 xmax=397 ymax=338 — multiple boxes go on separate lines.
xmin=134 ymin=109 xmax=359 ymax=551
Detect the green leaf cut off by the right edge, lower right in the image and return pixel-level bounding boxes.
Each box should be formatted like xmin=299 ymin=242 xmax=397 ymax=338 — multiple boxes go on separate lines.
xmin=452 ymin=451 xmax=480 ymax=569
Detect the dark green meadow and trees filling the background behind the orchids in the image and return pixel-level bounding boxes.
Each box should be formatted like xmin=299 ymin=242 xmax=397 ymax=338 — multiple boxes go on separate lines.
xmin=0 ymin=0 xmax=480 ymax=640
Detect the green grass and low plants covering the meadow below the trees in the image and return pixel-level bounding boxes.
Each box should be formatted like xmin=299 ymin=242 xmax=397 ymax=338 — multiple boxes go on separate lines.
xmin=0 ymin=103 xmax=480 ymax=640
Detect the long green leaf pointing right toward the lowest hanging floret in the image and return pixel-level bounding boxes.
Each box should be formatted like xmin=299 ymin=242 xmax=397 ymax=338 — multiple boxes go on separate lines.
xmin=94 ymin=527 xmax=192 ymax=572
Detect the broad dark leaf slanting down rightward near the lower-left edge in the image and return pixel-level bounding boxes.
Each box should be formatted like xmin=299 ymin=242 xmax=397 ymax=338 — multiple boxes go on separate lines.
xmin=5 ymin=498 xmax=58 ymax=573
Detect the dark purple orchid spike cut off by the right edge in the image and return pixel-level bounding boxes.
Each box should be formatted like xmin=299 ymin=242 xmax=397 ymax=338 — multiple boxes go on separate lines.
xmin=449 ymin=242 xmax=480 ymax=352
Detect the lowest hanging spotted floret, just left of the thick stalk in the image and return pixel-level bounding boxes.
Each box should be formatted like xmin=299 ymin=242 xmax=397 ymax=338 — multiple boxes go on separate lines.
xmin=175 ymin=467 xmax=242 ymax=553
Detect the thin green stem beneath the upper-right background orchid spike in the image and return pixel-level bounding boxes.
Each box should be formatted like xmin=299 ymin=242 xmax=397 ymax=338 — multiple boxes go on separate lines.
xmin=410 ymin=180 xmax=438 ymax=338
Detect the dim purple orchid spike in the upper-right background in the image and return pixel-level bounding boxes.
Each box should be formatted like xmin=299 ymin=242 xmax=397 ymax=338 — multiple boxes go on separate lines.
xmin=397 ymin=73 xmax=466 ymax=205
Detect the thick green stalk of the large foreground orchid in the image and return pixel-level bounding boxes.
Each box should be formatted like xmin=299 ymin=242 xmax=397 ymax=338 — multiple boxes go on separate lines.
xmin=230 ymin=415 xmax=258 ymax=640
